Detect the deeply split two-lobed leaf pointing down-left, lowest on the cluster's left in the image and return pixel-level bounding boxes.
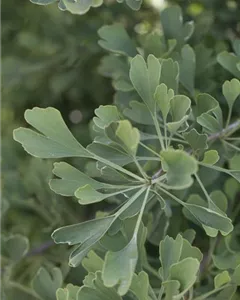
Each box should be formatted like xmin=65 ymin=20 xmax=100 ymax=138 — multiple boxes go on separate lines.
xmin=52 ymin=216 xmax=115 ymax=266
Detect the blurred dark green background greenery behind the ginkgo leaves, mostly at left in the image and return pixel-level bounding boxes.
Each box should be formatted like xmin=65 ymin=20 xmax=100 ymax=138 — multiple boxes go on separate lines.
xmin=0 ymin=0 xmax=240 ymax=300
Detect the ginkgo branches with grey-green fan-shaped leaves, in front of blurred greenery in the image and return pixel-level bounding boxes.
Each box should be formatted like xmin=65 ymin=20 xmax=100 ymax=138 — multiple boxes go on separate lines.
xmin=4 ymin=0 xmax=240 ymax=300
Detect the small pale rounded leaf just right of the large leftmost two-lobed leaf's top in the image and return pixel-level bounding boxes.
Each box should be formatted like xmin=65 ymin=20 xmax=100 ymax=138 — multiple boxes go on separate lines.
xmin=93 ymin=105 xmax=121 ymax=129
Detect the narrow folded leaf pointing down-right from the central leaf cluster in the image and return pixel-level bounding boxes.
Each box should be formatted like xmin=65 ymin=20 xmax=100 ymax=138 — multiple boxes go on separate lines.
xmin=185 ymin=203 xmax=233 ymax=235
